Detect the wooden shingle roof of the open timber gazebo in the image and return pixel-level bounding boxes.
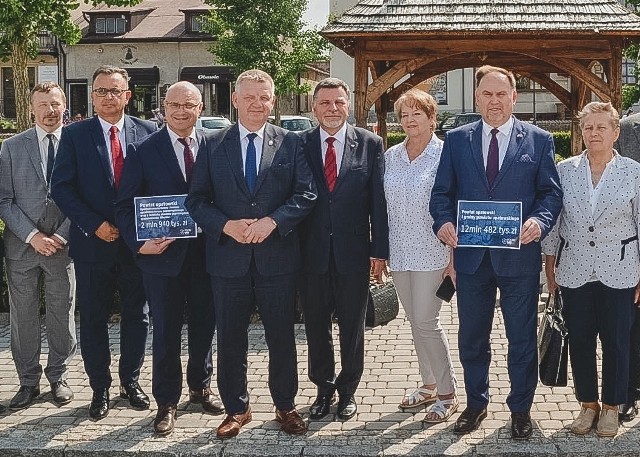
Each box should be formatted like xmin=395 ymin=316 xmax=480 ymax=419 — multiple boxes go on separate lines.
xmin=322 ymin=0 xmax=640 ymax=36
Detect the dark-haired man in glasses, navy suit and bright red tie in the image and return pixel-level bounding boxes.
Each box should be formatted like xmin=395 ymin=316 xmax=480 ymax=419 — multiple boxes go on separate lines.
xmin=51 ymin=66 xmax=157 ymax=420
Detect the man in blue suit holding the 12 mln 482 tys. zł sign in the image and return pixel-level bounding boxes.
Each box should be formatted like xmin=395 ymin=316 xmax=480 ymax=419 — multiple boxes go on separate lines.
xmin=429 ymin=65 xmax=562 ymax=439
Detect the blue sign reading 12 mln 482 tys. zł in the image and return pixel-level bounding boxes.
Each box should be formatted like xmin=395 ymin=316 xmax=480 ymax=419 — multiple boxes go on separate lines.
xmin=458 ymin=200 xmax=522 ymax=249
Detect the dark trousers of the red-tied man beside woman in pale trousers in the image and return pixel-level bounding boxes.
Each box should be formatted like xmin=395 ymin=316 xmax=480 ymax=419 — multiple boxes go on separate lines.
xmin=300 ymin=251 xmax=369 ymax=396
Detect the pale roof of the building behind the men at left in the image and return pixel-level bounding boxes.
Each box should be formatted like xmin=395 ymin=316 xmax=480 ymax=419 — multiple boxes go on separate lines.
xmin=72 ymin=0 xmax=210 ymax=42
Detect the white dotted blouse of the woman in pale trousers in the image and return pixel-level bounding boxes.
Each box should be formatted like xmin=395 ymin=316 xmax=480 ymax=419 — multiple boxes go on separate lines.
xmin=384 ymin=135 xmax=449 ymax=271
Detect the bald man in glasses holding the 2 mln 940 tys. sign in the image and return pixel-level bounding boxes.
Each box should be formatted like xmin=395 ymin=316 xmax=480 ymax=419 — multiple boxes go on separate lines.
xmin=116 ymin=82 xmax=224 ymax=435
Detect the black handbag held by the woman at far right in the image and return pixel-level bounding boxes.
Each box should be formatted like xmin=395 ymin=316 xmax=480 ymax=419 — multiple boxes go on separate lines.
xmin=538 ymin=288 xmax=569 ymax=387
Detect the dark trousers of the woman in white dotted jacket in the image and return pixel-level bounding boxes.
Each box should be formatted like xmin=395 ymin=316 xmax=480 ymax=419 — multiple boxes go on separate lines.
xmin=561 ymin=281 xmax=635 ymax=406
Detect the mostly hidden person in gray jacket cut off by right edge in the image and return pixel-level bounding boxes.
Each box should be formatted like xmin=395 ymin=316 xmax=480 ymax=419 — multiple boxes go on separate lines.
xmin=615 ymin=114 xmax=640 ymax=422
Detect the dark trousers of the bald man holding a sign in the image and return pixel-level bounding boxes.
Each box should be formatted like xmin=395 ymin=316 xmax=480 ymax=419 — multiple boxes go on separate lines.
xmin=143 ymin=240 xmax=216 ymax=405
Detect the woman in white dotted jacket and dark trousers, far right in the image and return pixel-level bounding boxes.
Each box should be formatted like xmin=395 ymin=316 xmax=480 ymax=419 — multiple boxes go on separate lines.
xmin=542 ymin=102 xmax=640 ymax=436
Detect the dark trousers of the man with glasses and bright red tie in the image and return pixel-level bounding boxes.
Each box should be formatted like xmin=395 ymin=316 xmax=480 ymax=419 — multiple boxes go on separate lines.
xmin=75 ymin=240 xmax=149 ymax=390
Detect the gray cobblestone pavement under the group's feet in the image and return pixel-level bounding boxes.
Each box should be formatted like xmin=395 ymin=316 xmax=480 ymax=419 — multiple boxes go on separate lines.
xmin=0 ymin=296 xmax=640 ymax=457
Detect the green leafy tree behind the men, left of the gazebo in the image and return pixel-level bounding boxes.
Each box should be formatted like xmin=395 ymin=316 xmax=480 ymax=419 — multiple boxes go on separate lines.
xmin=203 ymin=0 xmax=329 ymax=118
